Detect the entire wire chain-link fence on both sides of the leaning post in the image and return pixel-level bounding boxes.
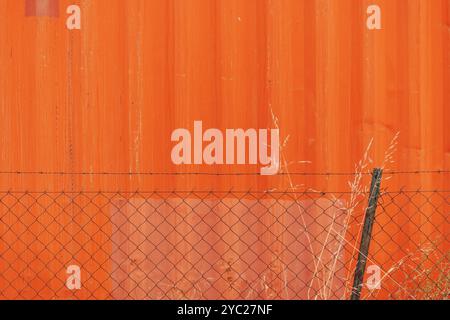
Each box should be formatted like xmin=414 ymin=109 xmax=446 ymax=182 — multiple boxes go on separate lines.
xmin=0 ymin=182 xmax=450 ymax=299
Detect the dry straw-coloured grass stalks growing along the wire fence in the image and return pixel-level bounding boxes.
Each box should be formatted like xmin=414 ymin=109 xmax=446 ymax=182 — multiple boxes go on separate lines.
xmin=147 ymin=127 xmax=450 ymax=300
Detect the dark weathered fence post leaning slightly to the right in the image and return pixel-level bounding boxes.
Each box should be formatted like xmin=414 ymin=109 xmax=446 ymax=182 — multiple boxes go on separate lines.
xmin=351 ymin=168 xmax=383 ymax=300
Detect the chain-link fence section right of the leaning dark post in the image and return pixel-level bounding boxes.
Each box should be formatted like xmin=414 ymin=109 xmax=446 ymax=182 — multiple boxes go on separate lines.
xmin=365 ymin=191 xmax=450 ymax=300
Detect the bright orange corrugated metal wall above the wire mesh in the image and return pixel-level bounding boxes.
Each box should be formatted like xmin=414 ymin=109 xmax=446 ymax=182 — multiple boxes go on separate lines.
xmin=0 ymin=0 xmax=450 ymax=300
